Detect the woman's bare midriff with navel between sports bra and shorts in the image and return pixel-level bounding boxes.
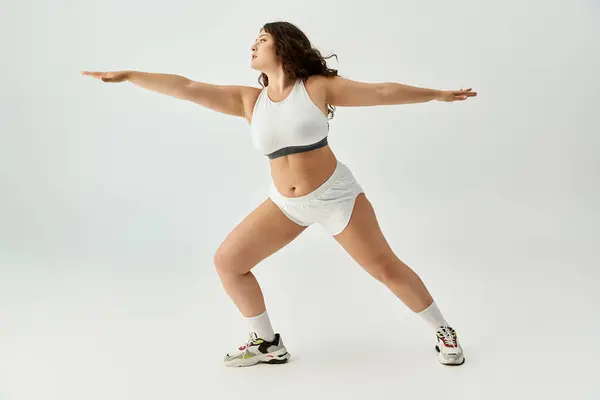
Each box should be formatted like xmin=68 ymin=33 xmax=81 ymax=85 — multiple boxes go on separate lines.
xmin=270 ymin=145 xmax=337 ymax=197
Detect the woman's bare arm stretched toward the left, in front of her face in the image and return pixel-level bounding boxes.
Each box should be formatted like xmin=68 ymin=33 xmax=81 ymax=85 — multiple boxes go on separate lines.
xmin=82 ymin=71 xmax=260 ymax=120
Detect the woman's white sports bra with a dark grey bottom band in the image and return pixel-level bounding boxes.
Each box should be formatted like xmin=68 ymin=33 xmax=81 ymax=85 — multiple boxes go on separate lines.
xmin=250 ymin=79 xmax=329 ymax=159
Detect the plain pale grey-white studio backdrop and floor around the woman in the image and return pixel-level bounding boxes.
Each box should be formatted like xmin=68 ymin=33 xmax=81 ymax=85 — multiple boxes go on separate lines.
xmin=0 ymin=0 xmax=600 ymax=400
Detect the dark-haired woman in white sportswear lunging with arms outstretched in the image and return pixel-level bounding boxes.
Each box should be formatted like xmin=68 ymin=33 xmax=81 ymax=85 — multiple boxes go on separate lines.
xmin=82 ymin=22 xmax=476 ymax=366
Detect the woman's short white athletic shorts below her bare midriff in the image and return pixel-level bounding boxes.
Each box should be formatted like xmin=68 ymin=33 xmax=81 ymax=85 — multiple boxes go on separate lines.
xmin=269 ymin=161 xmax=363 ymax=236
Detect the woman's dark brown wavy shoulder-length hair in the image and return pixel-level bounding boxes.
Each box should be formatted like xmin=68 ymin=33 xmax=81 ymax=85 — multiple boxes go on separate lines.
xmin=258 ymin=21 xmax=339 ymax=119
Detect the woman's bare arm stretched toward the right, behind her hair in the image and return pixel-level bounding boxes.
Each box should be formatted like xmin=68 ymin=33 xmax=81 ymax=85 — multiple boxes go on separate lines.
xmin=324 ymin=76 xmax=477 ymax=107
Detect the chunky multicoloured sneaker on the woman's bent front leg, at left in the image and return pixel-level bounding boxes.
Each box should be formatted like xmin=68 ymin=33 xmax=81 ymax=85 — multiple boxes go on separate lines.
xmin=223 ymin=332 xmax=290 ymax=367
